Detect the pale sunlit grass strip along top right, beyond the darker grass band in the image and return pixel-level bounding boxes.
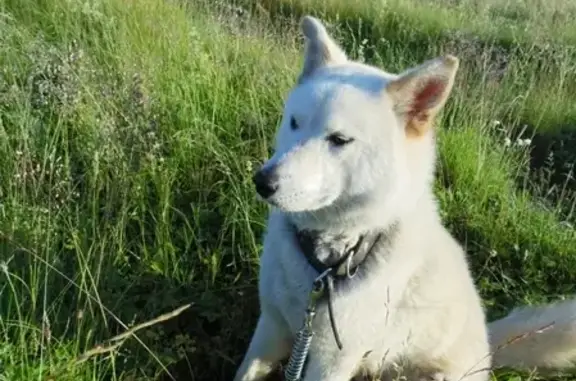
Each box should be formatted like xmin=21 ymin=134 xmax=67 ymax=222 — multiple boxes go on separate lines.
xmin=254 ymin=0 xmax=576 ymax=45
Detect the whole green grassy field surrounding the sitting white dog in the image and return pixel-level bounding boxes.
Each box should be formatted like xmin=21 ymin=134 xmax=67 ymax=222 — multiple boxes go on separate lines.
xmin=0 ymin=0 xmax=576 ymax=381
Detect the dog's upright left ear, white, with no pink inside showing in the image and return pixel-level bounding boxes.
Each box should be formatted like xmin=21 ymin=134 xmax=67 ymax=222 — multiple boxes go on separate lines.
xmin=298 ymin=16 xmax=348 ymax=82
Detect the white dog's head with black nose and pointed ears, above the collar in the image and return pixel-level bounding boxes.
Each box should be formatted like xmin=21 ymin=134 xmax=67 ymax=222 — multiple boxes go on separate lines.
xmin=253 ymin=16 xmax=458 ymax=226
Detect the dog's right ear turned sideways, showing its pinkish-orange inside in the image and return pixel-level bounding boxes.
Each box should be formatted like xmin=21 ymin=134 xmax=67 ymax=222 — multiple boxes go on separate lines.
xmin=386 ymin=55 xmax=459 ymax=137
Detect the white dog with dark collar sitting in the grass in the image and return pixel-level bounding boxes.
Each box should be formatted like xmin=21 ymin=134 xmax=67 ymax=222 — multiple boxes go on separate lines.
xmin=235 ymin=16 xmax=576 ymax=381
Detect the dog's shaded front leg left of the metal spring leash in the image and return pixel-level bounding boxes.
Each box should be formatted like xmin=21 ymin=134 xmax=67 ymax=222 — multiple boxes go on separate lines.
xmin=234 ymin=311 xmax=291 ymax=381
